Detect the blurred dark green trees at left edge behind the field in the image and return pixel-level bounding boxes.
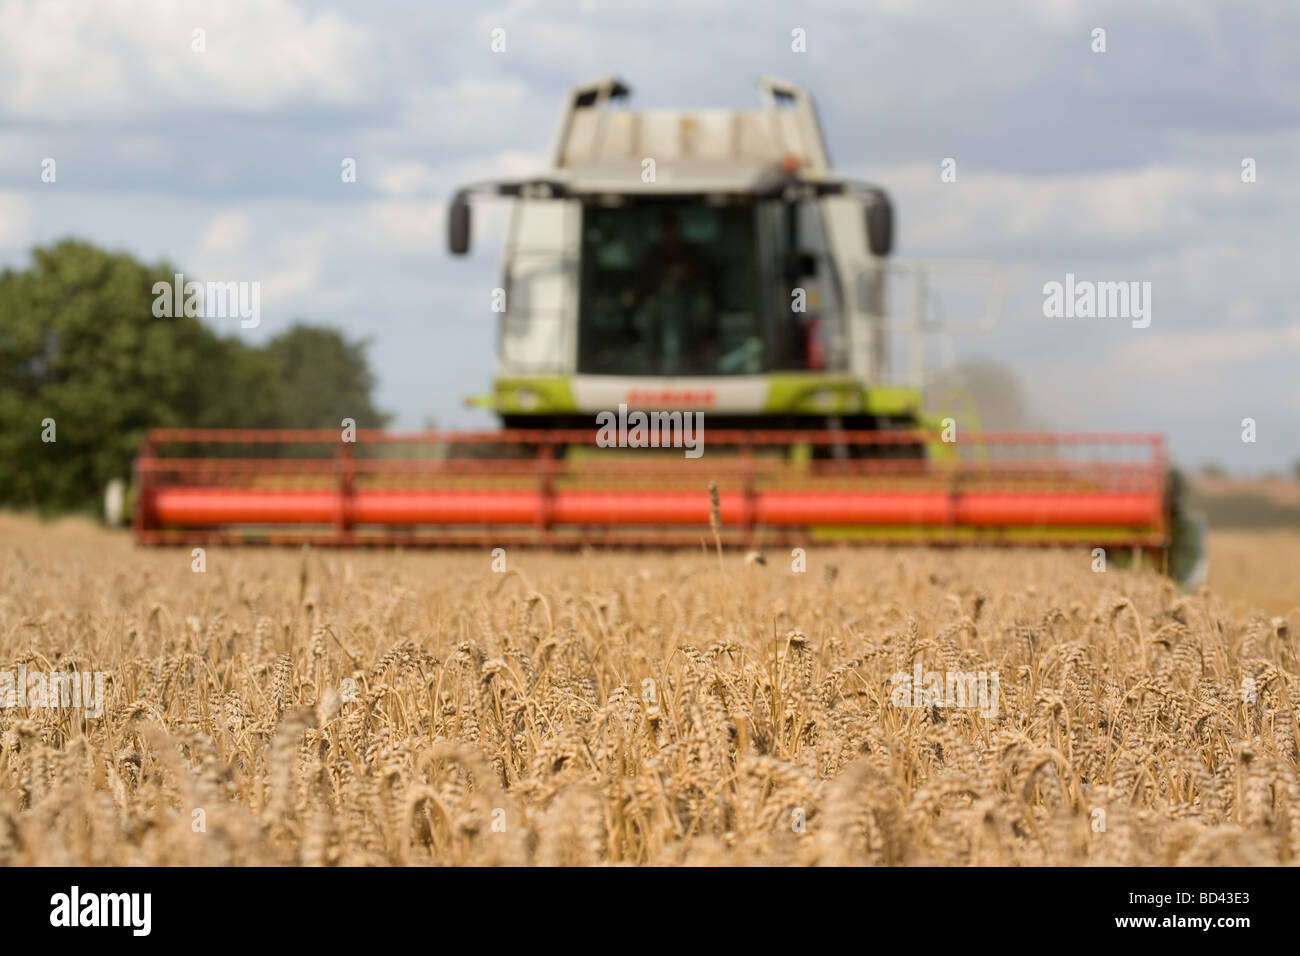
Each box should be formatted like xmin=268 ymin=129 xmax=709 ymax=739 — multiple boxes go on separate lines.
xmin=0 ymin=241 xmax=386 ymax=511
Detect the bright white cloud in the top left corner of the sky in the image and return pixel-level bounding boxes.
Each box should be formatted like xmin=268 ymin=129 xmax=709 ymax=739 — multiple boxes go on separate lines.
xmin=0 ymin=0 xmax=382 ymax=122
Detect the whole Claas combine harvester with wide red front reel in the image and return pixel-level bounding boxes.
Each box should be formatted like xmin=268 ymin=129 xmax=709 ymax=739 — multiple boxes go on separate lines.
xmin=134 ymin=78 xmax=1177 ymax=564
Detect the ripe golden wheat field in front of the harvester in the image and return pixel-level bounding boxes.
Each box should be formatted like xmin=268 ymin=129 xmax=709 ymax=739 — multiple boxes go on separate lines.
xmin=0 ymin=515 xmax=1300 ymax=865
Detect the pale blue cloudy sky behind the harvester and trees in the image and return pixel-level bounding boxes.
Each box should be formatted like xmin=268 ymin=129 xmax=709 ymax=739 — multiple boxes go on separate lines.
xmin=0 ymin=0 xmax=1300 ymax=473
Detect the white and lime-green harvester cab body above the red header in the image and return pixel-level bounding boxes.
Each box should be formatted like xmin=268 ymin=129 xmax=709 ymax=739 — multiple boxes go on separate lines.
xmin=449 ymin=77 xmax=956 ymax=429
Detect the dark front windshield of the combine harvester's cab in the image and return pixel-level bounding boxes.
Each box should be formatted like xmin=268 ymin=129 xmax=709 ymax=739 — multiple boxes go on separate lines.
xmin=579 ymin=202 xmax=764 ymax=375
